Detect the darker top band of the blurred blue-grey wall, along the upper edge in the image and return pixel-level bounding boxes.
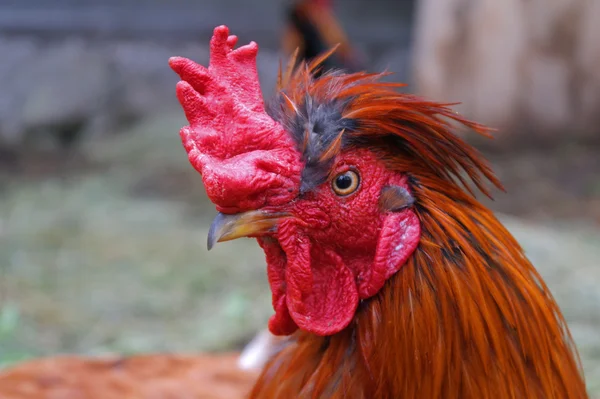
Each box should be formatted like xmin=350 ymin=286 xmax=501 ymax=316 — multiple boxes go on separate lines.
xmin=0 ymin=0 xmax=413 ymax=47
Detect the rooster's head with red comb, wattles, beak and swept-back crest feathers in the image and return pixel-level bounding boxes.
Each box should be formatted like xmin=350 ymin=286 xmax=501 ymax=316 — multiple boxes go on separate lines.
xmin=170 ymin=26 xmax=496 ymax=336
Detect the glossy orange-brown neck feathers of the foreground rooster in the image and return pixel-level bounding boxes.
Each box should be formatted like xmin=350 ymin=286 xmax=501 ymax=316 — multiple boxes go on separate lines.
xmin=251 ymin=187 xmax=587 ymax=399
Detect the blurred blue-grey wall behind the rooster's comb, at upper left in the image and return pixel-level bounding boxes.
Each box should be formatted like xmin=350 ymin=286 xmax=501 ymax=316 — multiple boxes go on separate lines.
xmin=0 ymin=0 xmax=413 ymax=145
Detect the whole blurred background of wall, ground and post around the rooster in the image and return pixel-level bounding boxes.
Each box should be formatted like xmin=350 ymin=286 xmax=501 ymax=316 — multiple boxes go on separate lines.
xmin=0 ymin=0 xmax=600 ymax=393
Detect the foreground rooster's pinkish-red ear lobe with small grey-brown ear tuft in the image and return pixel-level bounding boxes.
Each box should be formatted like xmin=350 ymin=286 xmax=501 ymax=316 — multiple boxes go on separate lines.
xmin=359 ymin=186 xmax=421 ymax=299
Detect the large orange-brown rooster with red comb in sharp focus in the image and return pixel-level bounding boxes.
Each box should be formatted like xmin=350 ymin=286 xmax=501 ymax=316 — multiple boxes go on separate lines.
xmin=0 ymin=26 xmax=587 ymax=399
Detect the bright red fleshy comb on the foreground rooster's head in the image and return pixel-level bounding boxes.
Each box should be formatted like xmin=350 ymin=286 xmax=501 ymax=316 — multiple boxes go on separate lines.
xmin=169 ymin=26 xmax=300 ymax=212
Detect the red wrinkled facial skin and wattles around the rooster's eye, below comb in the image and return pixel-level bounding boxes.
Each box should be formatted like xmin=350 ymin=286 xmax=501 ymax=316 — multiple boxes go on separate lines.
xmin=259 ymin=149 xmax=420 ymax=335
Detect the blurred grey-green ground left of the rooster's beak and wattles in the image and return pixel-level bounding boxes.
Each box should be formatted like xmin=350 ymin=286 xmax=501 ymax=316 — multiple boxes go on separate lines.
xmin=0 ymin=114 xmax=270 ymax=361
